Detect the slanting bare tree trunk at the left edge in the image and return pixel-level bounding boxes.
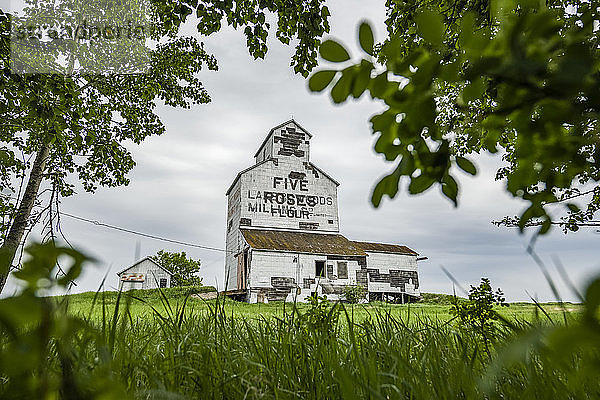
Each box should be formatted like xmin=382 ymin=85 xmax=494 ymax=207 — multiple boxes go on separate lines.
xmin=0 ymin=144 xmax=50 ymax=293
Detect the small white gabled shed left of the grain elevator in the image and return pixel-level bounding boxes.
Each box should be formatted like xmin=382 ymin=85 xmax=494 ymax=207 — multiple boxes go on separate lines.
xmin=117 ymin=257 xmax=173 ymax=291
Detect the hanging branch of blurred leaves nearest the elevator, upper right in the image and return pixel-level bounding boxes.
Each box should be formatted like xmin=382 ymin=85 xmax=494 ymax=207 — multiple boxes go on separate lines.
xmin=309 ymin=21 xmax=476 ymax=206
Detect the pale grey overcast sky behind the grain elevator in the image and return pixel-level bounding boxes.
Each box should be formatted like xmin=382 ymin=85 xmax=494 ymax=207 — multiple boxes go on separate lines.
xmin=5 ymin=0 xmax=600 ymax=301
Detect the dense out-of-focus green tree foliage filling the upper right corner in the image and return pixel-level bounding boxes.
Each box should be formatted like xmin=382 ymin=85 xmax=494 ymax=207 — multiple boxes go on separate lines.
xmin=309 ymin=1 xmax=600 ymax=233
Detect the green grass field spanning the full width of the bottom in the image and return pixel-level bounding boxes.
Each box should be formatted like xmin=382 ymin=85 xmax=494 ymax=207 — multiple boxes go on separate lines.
xmin=0 ymin=288 xmax=600 ymax=400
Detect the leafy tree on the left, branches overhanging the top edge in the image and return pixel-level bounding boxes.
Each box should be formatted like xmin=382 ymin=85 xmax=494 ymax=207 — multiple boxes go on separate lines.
xmin=0 ymin=0 xmax=329 ymax=291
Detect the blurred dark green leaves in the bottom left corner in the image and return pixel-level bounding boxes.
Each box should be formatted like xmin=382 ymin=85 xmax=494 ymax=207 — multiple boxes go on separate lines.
xmin=0 ymin=243 xmax=126 ymax=399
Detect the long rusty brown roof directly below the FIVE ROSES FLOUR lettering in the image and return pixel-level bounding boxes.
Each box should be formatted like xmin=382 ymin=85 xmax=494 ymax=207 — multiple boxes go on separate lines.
xmin=240 ymin=229 xmax=367 ymax=256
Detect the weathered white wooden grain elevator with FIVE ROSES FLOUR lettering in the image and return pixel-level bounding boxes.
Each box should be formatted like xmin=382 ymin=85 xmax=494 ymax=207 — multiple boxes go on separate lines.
xmin=225 ymin=120 xmax=420 ymax=303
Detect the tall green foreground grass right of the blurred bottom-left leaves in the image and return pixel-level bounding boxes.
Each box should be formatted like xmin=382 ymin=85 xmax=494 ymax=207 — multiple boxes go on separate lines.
xmin=72 ymin=290 xmax=600 ymax=399
